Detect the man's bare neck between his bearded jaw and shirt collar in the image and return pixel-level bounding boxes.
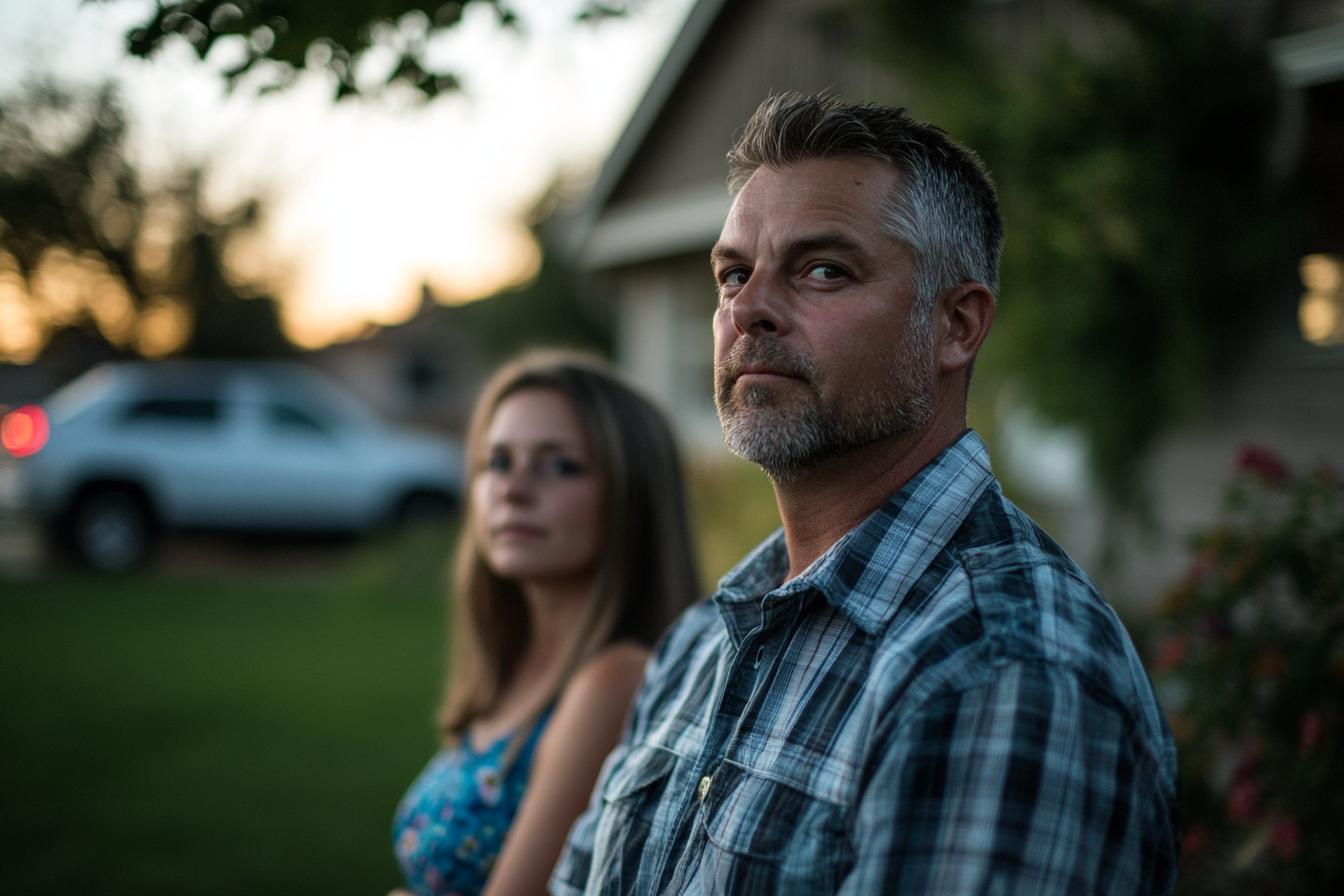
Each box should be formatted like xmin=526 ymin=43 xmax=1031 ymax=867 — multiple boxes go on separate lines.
xmin=774 ymin=418 xmax=965 ymax=580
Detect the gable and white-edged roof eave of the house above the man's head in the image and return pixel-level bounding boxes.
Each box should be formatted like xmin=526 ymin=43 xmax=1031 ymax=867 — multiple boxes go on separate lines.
xmin=564 ymin=0 xmax=887 ymax=270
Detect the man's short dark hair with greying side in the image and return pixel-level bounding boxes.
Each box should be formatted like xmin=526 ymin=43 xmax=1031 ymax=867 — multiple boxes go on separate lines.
xmin=728 ymin=93 xmax=1004 ymax=313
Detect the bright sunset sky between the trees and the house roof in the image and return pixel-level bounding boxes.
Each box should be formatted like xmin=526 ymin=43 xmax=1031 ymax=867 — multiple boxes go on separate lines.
xmin=0 ymin=0 xmax=689 ymax=345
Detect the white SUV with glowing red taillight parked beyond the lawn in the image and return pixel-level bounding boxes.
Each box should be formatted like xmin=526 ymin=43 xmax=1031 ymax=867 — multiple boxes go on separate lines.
xmin=7 ymin=361 xmax=462 ymax=570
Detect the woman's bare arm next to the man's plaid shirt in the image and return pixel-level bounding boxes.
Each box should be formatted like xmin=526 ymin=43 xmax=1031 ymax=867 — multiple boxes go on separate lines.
xmin=482 ymin=643 xmax=649 ymax=896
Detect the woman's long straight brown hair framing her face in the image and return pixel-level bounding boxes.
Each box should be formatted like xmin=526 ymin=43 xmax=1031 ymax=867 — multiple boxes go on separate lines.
xmin=438 ymin=351 xmax=699 ymax=743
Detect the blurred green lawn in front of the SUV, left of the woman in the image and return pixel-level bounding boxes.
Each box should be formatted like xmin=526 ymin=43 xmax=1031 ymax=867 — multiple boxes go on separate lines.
xmin=0 ymin=531 xmax=449 ymax=896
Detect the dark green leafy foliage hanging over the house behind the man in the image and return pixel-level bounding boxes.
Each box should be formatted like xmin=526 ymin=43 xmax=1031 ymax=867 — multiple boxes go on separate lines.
xmin=868 ymin=0 xmax=1301 ymax=506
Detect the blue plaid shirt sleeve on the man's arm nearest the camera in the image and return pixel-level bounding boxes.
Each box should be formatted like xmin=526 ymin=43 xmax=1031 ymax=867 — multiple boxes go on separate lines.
xmin=840 ymin=661 xmax=1179 ymax=896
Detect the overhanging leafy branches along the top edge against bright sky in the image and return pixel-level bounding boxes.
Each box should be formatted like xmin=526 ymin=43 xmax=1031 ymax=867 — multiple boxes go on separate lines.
xmin=93 ymin=0 xmax=630 ymax=99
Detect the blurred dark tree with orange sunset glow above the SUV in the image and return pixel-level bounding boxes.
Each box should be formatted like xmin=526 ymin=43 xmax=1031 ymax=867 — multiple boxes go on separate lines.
xmin=0 ymin=85 xmax=292 ymax=360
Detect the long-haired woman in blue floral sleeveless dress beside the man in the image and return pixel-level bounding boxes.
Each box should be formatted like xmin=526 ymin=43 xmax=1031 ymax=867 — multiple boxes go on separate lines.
xmin=394 ymin=353 xmax=698 ymax=896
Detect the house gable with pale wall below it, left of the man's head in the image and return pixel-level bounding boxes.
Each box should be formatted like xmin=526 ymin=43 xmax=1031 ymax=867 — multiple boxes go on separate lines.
xmin=561 ymin=0 xmax=892 ymax=453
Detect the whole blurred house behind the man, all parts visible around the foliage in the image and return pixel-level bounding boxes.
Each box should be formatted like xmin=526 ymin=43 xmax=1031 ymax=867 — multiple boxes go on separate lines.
xmin=570 ymin=0 xmax=1344 ymax=609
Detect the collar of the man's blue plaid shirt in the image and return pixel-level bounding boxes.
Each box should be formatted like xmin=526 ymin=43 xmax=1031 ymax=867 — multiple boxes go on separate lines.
xmin=714 ymin=430 xmax=993 ymax=642
